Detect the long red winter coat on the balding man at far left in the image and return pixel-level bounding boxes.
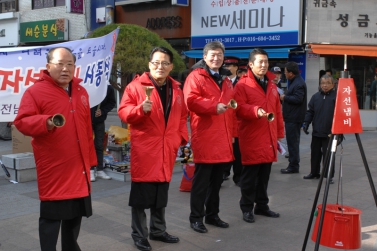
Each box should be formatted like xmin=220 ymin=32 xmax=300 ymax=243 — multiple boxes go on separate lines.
xmin=14 ymin=71 xmax=97 ymax=201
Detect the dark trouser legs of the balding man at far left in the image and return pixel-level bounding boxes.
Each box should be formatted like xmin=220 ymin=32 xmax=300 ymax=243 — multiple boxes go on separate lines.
xmin=39 ymin=216 xmax=82 ymax=251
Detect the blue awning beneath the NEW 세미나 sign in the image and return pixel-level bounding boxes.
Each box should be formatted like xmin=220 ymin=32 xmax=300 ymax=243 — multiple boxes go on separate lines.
xmin=183 ymin=47 xmax=295 ymax=58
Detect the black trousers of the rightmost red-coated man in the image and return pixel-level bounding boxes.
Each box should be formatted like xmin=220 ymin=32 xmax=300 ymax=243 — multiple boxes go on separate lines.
xmin=240 ymin=163 xmax=270 ymax=213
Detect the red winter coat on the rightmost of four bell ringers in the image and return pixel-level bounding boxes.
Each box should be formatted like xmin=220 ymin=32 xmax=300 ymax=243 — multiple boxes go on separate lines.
xmin=234 ymin=69 xmax=284 ymax=165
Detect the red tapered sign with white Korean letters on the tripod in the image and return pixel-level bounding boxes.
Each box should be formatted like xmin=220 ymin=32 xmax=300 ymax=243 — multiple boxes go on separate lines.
xmin=331 ymin=78 xmax=363 ymax=134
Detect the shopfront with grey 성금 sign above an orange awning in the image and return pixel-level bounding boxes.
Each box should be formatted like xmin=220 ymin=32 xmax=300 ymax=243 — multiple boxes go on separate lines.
xmin=304 ymin=0 xmax=377 ymax=130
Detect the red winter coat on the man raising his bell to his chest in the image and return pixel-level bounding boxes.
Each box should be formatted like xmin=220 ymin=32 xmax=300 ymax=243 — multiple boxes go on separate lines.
xmin=118 ymin=73 xmax=188 ymax=182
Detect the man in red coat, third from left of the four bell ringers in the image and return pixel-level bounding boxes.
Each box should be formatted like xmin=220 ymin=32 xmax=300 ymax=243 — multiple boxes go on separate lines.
xmin=183 ymin=42 xmax=234 ymax=233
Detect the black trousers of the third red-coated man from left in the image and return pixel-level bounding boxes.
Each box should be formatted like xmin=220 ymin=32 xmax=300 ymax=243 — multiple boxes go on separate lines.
xmin=190 ymin=163 xmax=229 ymax=223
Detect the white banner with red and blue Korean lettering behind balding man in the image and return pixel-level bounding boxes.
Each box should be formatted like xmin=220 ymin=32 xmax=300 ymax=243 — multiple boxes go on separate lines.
xmin=0 ymin=29 xmax=119 ymax=122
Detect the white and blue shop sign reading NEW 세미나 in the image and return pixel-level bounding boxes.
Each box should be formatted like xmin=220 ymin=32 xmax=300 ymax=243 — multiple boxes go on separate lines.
xmin=191 ymin=0 xmax=302 ymax=49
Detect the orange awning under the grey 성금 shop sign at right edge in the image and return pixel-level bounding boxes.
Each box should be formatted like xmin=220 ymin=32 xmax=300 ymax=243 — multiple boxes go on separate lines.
xmin=309 ymin=44 xmax=377 ymax=57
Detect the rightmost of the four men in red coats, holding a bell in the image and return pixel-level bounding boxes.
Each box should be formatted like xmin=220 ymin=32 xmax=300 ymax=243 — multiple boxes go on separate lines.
xmin=234 ymin=49 xmax=284 ymax=223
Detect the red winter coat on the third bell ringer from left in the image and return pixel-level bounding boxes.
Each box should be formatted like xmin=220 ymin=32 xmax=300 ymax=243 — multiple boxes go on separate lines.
xmin=183 ymin=61 xmax=234 ymax=163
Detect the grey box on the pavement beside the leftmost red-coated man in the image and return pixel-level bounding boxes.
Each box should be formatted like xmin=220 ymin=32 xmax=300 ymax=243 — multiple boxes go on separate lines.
xmin=2 ymin=152 xmax=37 ymax=183
